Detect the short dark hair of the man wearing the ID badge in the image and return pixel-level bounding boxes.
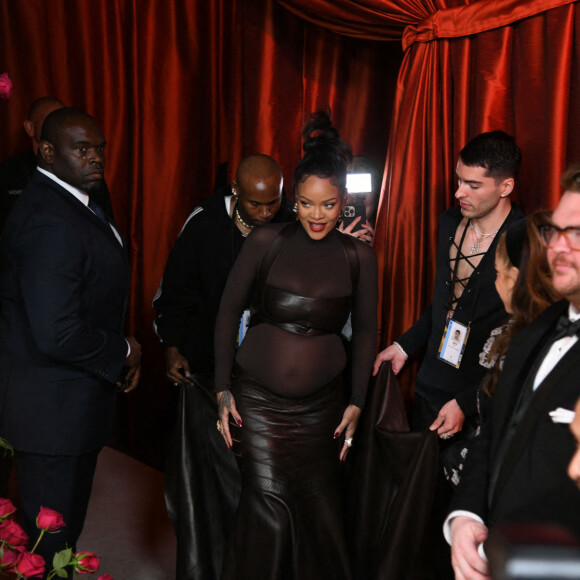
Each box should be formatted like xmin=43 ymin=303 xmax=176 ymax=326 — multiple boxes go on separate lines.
xmin=459 ymin=131 xmax=522 ymax=180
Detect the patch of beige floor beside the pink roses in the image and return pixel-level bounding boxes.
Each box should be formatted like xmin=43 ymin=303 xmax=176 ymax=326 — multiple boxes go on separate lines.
xmin=78 ymin=447 xmax=176 ymax=580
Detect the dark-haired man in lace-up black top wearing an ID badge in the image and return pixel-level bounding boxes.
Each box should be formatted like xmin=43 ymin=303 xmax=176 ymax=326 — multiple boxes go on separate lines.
xmin=374 ymin=131 xmax=523 ymax=578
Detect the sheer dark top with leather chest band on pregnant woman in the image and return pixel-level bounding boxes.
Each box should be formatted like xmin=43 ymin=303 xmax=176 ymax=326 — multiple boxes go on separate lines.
xmin=215 ymin=224 xmax=377 ymax=407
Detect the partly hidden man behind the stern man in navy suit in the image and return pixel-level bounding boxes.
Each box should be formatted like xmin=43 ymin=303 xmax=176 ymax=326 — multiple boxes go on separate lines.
xmin=0 ymin=96 xmax=113 ymax=237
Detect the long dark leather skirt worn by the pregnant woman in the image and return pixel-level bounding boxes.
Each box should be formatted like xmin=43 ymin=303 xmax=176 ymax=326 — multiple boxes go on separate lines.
xmin=222 ymin=367 xmax=351 ymax=580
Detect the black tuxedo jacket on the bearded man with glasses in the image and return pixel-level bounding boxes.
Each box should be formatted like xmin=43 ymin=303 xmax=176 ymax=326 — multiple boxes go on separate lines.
xmin=451 ymin=301 xmax=580 ymax=537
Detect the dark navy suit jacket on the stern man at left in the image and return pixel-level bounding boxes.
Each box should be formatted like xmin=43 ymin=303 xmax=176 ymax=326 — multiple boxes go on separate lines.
xmin=0 ymin=171 xmax=130 ymax=455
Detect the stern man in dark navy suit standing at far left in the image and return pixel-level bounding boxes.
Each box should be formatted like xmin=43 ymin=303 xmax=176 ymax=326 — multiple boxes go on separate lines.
xmin=0 ymin=108 xmax=141 ymax=569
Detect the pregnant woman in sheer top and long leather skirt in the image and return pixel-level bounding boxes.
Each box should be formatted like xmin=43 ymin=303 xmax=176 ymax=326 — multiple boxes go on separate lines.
xmin=215 ymin=113 xmax=377 ymax=580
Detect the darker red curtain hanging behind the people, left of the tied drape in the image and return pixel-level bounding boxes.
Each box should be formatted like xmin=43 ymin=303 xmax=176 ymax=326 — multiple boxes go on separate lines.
xmin=0 ymin=0 xmax=402 ymax=459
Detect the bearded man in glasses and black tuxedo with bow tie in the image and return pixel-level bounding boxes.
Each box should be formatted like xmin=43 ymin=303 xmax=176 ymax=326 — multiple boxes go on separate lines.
xmin=444 ymin=165 xmax=580 ymax=580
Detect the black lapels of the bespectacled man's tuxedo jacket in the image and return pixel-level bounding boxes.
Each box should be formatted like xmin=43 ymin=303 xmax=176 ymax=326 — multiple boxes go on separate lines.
xmin=490 ymin=301 xmax=580 ymax=509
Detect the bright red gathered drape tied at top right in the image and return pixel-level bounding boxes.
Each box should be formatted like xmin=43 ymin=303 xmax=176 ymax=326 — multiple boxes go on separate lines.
xmin=278 ymin=0 xmax=580 ymax=368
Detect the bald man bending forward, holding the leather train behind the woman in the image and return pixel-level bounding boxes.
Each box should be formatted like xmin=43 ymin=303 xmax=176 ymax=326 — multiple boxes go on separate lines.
xmin=153 ymin=155 xmax=294 ymax=580
